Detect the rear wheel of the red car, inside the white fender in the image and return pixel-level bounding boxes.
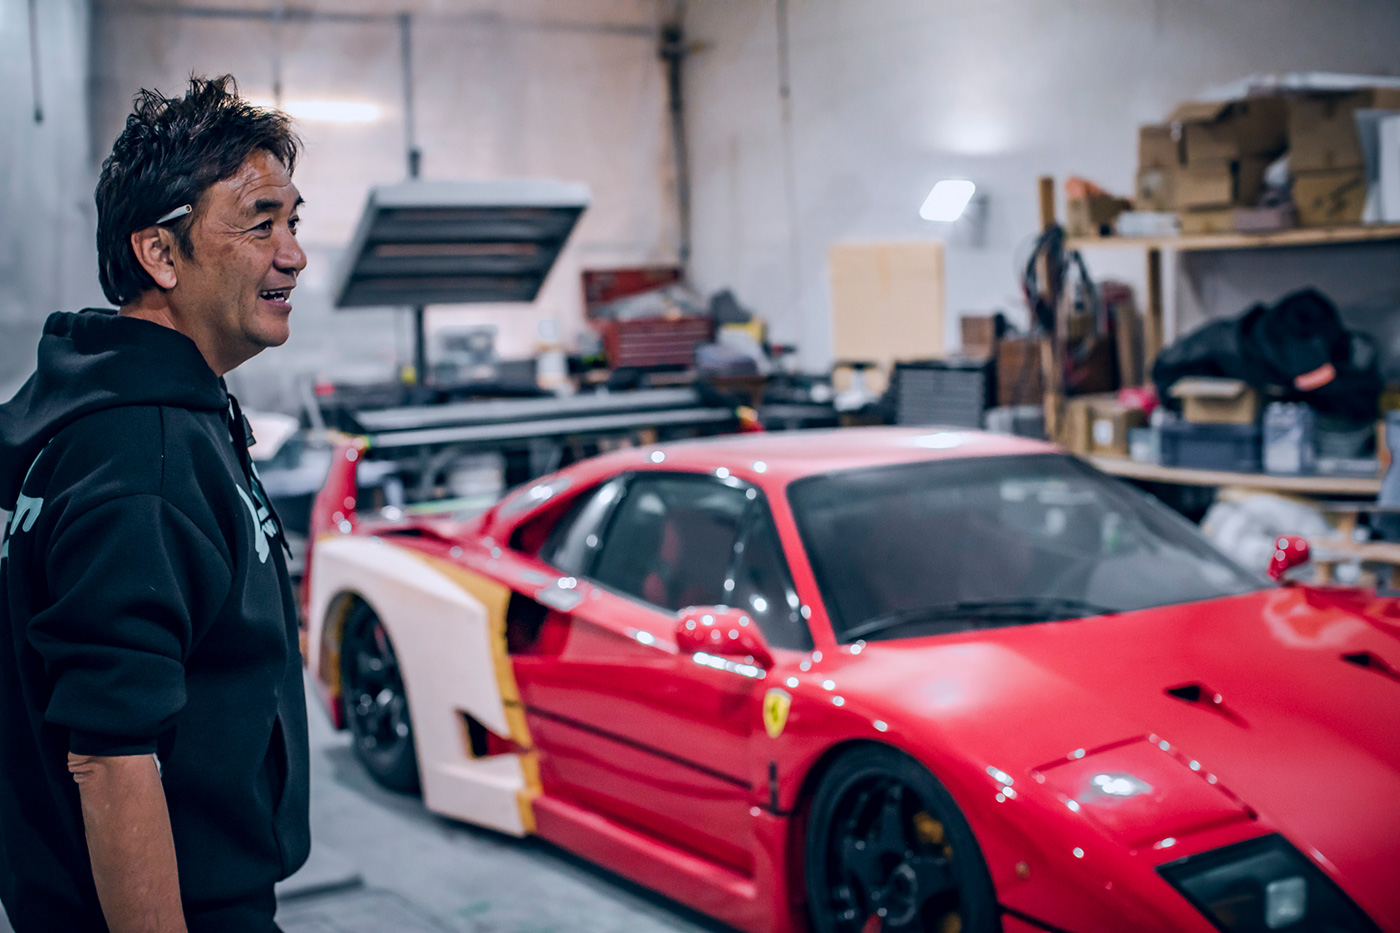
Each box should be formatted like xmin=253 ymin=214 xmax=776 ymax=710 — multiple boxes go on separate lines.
xmin=340 ymin=604 xmax=419 ymax=793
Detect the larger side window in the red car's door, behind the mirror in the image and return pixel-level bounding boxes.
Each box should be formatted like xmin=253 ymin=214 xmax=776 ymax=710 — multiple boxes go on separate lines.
xmin=588 ymin=474 xmax=749 ymax=611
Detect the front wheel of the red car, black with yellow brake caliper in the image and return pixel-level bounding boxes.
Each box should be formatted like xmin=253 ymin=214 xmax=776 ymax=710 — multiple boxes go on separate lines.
xmin=805 ymin=745 xmax=1001 ymax=933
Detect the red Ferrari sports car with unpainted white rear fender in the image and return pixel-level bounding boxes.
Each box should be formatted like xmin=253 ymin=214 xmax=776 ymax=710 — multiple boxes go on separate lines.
xmin=307 ymin=429 xmax=1400 ymax=933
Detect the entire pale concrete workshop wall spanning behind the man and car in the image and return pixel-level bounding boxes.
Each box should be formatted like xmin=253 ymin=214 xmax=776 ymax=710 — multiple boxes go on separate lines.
xmin=13 ymin=0 xmax=1400 ymax=406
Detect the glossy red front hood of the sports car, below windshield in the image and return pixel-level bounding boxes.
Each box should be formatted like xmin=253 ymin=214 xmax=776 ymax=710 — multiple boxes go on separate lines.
xmin=840 ymin=588 xmax=1400 ymax=913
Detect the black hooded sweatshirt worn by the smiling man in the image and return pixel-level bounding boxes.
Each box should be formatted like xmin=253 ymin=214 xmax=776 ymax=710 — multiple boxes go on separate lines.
xmin=0 ymin=310 xmax=309 ymax=933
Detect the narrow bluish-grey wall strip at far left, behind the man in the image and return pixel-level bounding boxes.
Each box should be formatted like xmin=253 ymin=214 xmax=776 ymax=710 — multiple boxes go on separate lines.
xmin=0 ymin=0 xmax=102 ymax=399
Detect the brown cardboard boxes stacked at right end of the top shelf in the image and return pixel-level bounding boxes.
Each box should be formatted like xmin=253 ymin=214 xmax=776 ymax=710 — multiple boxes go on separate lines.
xmin=1288 ymin=87 xmax=1400 ymax=227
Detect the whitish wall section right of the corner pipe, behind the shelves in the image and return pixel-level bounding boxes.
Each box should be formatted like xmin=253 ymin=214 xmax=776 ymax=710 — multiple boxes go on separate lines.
xmin=686 ymin=0 xmax=1400 ymax=367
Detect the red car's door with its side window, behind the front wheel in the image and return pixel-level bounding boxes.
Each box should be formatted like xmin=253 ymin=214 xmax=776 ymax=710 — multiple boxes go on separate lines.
xmin=512 ymin=471 xmax=805 ymax=873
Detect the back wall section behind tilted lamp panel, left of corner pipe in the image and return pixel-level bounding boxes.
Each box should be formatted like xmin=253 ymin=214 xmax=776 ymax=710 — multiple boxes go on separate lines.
xmin=87 ymin=0 xmax=678 ymax=408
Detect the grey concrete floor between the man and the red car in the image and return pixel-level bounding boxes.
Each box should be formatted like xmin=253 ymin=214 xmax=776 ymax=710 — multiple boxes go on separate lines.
xmin=0 ymin=675 xmax=731 ymax=933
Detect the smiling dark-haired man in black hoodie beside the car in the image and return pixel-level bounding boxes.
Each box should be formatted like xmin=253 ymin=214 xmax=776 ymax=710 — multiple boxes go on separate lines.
xmin=0 ymin=76 xmax=309 ymax=933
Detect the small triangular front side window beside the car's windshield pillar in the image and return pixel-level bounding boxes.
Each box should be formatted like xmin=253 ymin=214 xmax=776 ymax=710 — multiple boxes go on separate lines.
xmin=724 ymin=502 xmax=812 ymax=651
